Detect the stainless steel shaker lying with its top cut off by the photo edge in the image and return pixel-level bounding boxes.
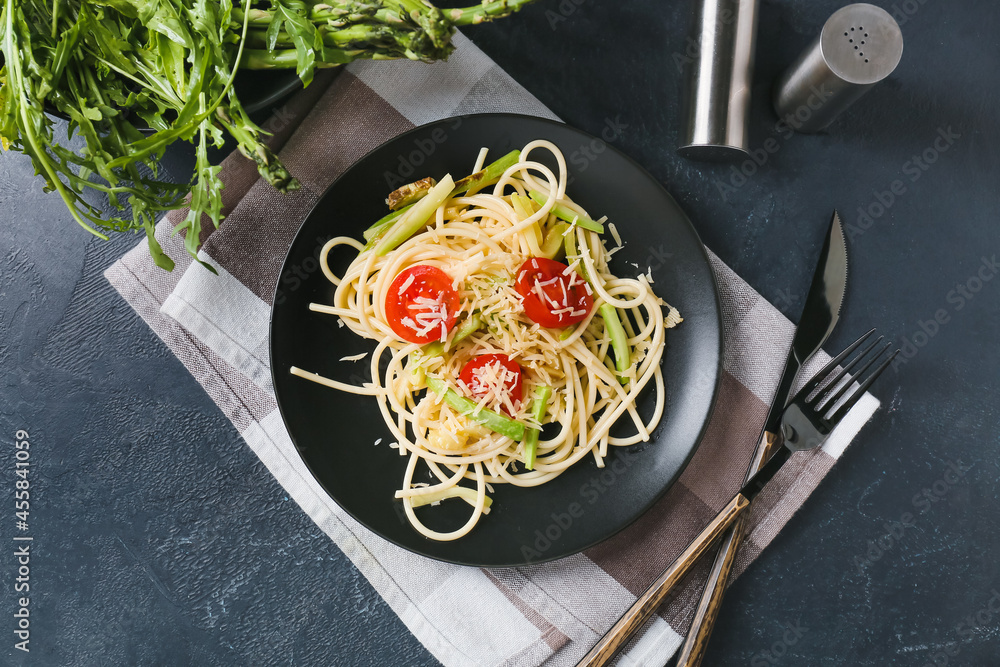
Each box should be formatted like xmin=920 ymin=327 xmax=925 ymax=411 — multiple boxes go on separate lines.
xmin=677 ymin=0 xmax=759 ymax=161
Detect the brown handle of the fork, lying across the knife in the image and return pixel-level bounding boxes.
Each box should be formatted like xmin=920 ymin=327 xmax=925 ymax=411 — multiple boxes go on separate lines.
xmin=577 ymin=494 xmax=750 ymax=667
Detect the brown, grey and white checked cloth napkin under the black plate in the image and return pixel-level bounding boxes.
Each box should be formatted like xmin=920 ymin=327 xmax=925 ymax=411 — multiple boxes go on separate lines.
xmin=105 ymin=35 xmax=879 ymax=667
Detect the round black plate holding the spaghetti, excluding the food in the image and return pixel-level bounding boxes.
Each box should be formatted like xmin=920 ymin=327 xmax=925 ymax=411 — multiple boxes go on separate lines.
xmin=271 ymin=114 xmax=722 ymax=567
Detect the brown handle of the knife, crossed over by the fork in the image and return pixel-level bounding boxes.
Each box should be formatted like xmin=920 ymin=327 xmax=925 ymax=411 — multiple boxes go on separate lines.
xmin=677 ymin=431 xmax=781 ymax=667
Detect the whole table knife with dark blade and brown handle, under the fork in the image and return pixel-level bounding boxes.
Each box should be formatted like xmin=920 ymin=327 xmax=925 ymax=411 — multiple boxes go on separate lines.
xmin=677 ymin=211 xmax=847 ymax=667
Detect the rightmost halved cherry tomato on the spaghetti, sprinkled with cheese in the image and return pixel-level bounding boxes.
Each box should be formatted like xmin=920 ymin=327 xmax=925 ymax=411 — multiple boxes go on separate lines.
xmin=515 ymin=257 xmax=594 ymax=328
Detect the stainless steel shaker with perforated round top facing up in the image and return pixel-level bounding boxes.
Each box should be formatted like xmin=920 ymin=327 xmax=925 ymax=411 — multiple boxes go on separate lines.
xmin=773 ymin=3 xmax=903 ymax=133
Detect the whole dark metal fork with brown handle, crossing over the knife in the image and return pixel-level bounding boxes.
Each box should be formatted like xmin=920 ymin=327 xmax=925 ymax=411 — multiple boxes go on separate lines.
xmin=578 ymin=329 xmax=899 ymax=667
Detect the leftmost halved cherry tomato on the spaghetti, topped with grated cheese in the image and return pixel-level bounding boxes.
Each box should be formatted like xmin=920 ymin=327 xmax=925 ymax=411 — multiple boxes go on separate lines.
xmin=385 ymin=264 xmax=459 ymax=344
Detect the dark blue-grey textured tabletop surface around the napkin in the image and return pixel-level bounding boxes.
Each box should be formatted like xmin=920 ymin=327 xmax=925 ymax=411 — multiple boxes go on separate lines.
xmin=0 ymin=0 xmax=1000 ymax=667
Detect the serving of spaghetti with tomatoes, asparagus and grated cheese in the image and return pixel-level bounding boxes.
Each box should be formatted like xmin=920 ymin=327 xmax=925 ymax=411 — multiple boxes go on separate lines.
xmin=291 ymin=140 xmax=681 ymax=540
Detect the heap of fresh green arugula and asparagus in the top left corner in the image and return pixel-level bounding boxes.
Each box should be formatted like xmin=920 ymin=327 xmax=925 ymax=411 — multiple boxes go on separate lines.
xmin=0 ymin=0 xmax=533 ymax=270
